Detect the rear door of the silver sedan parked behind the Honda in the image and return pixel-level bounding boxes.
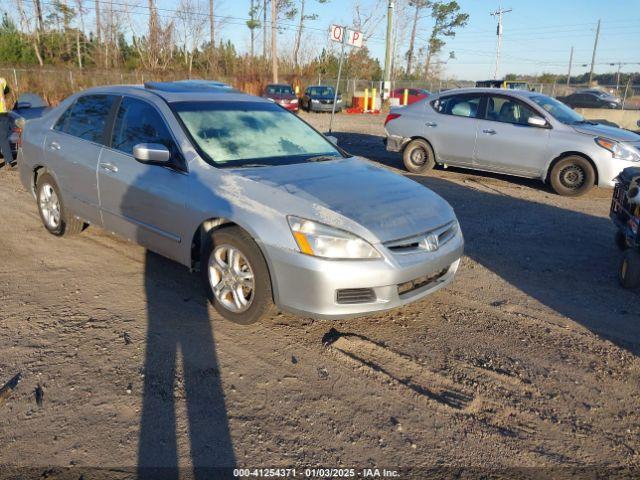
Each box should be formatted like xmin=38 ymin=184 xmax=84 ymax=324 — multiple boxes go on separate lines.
xmin=428 ymin=93 xmax=482 ymax=166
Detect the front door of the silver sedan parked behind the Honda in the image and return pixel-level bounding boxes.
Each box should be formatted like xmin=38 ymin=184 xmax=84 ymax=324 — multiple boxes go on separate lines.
xmin=474 ymin=95 xmax=551 ymax=177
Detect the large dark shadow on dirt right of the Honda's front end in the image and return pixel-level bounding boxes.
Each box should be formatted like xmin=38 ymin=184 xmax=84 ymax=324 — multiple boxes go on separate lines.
xmin=409 ymin=175 xmax=640 ymax=355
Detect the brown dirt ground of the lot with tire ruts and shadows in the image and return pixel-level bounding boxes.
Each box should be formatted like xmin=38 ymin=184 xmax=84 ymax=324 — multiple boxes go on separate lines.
xmin=0 ymin=114 xmax=640 ymax=478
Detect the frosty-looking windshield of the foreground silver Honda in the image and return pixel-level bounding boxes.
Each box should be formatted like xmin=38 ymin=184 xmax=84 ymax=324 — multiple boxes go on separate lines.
xmin=173 ymin=101 xmax=342 ymax=167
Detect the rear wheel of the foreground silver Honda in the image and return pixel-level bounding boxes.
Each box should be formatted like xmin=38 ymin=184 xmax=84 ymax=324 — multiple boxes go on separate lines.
xmin=36 ymin=173 xmax=85 ymax=237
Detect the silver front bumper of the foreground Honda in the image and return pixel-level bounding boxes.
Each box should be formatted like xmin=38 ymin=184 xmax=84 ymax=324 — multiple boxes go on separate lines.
xmin=263 ymin=232 xmax=464 ymax=319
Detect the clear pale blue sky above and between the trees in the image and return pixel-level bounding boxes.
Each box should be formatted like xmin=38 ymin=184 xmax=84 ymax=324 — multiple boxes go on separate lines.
xmin=10 ymin=0 xmax=640 ymax=80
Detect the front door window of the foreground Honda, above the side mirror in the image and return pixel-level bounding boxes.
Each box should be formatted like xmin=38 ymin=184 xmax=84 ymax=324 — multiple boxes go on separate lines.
xmin=111 ymin=97 xmax=175 ymax=155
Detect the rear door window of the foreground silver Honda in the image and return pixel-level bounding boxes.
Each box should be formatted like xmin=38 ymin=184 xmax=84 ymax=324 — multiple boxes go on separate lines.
xmin=53 ymin=95 xmax=116 ymax=143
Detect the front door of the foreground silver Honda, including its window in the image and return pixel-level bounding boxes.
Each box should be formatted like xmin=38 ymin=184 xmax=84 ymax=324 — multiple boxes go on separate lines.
xmin=98 ymin=96 xmax=191 ymax=260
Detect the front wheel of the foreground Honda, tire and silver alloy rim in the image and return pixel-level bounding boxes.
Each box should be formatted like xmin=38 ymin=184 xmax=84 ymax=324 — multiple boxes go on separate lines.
xmin=201 ymin=226 xmax=275 ymax=325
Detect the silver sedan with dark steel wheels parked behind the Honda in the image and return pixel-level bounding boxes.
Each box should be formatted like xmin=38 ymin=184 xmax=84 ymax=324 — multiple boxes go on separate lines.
xmin=385 ymin=88 xmax=640 ymax=195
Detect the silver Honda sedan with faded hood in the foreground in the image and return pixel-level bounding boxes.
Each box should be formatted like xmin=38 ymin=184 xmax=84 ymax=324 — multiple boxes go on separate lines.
xmin=18 ymin=83 xmax=463 ymax=323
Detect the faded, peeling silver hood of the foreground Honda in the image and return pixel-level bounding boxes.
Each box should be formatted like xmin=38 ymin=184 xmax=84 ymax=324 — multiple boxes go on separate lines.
xmin=234 ymin=158 xmax=455 ymax=242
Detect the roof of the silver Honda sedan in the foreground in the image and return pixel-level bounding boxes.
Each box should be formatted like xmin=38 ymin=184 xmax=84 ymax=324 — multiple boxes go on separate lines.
xmin=70 ymin=82 xmax=270 ymax=103
